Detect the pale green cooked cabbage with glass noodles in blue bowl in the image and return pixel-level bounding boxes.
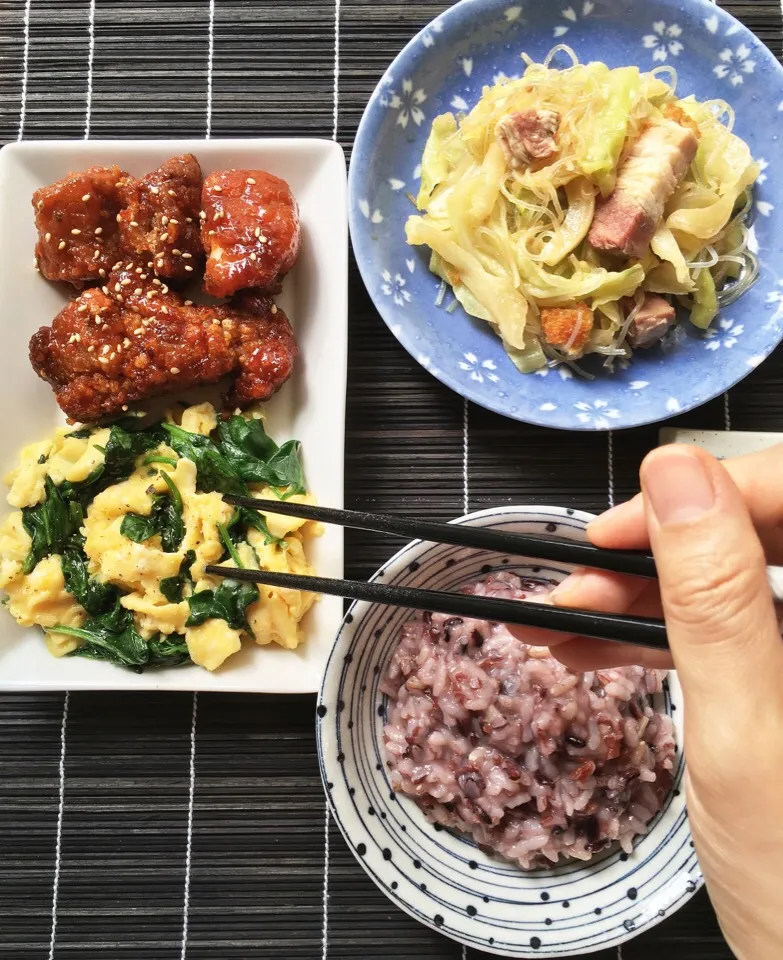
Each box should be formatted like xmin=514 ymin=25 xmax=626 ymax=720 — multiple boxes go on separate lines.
xmin=406 ymin=46 xmax=759 ymax=373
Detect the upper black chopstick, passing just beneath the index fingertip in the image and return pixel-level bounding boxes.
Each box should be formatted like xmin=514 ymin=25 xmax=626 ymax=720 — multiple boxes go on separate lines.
xmin=223 ymin=496 xmax=657 ymax=579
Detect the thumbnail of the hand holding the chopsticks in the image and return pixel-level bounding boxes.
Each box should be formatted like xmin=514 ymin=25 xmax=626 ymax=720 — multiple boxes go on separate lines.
xmin=642 ymin=447 xmax=715 ymax=526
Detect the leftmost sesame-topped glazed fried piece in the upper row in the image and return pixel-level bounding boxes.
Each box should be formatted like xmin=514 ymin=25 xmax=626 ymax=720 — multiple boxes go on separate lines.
xmin=33 ymin=167 xmax=128 ymax=289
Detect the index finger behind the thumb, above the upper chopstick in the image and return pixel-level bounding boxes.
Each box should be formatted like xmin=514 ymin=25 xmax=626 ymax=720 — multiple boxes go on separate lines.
xmin=587 ymin=444 xmax=783 ymax=564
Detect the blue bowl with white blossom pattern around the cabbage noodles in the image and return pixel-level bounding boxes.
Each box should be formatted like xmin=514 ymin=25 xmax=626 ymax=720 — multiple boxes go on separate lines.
xmin=350 ymin=0 xmax=783 ymax=430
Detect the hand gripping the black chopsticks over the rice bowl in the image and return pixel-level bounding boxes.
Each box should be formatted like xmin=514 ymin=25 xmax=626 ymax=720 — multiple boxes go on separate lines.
xmin=520 ymin=446 xmax=783 ymax=960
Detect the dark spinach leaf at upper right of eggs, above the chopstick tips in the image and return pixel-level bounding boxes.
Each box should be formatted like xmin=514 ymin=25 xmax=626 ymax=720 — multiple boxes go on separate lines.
xmin=218 ymin=416 xmax=305 ymax=497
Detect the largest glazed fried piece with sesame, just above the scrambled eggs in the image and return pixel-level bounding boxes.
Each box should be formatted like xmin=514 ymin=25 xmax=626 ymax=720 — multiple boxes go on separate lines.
xmin=30 ymin=264 xmax=297 ymax=423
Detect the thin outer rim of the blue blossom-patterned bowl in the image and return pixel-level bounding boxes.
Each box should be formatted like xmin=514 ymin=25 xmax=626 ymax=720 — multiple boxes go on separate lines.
xmin=348 ymin=0 xmax=783 ymax=433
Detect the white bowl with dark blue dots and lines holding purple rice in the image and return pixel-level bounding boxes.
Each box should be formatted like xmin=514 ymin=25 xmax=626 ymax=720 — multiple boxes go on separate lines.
xmin=317 ymin=508 xmax=702 ymax=957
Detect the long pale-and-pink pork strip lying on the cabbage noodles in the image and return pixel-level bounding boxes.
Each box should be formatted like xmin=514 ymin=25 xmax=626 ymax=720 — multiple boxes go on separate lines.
xmin=588 ymin=120 xmax=699 ymax=257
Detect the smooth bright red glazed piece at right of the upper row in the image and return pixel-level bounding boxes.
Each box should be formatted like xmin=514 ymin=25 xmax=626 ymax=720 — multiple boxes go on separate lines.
xmin=201 ymin=170 xmax=299 ymax=297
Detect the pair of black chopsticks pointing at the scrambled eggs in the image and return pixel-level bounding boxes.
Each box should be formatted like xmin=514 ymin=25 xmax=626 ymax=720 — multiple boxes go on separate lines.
xmin=206 ymin=496 xmax=668 ymax=650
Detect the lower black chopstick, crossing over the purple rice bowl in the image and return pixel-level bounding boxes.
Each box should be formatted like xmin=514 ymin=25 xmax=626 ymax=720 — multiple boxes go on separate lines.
xmin=206 ymin=564 xmax=669 ymax=650
